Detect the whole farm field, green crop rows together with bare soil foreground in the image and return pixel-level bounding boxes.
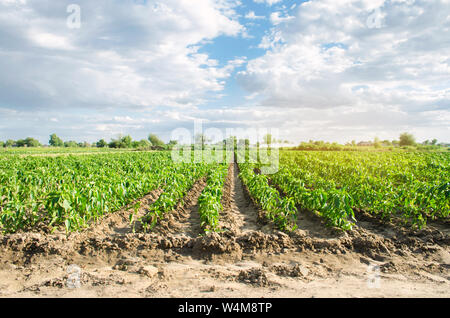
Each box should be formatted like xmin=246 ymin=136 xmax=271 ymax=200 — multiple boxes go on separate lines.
xmin=0 ymin=151 xmax=450 ymax=297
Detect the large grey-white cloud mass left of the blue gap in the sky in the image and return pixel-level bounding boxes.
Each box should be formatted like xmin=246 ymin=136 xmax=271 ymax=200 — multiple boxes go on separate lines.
xmin=0 ymin=0 xmax=243 ymax=112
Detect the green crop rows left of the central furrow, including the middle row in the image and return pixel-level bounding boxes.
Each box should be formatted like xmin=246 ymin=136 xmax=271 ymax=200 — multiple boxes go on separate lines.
xmin=0 ymin=149 xmax=236 ymax=233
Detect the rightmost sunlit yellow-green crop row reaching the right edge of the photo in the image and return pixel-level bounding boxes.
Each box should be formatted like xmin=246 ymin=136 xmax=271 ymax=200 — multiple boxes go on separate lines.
xmin=282 ymin=153 xmax=450 ymax=228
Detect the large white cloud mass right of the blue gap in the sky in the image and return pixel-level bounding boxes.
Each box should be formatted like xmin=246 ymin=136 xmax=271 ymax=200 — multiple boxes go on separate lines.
xmin=238 ymin=0 xmax=450 ymax=140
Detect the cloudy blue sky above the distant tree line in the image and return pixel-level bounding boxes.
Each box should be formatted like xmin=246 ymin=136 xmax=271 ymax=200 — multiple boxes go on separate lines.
xmin=0 ymin=0 xmax=450 ymax=143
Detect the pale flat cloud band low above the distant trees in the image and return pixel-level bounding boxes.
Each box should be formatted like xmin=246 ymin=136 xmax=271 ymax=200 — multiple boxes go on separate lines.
xmin=0 ymin=97 xmax=450 ymax=143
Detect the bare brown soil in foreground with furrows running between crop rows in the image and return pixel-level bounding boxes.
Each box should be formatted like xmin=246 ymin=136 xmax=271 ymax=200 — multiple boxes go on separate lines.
xmin=0 ymin=164 xmax=450 ymax=298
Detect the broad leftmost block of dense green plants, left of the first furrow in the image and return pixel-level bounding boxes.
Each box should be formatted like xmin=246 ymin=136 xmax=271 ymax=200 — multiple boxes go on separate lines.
xmin=0 ymin=153 xmax=172 ymax=232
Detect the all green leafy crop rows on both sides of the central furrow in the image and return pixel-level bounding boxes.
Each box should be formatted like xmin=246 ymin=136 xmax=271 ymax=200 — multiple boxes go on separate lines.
xmin=0 ymin=149 xmax=450 ymax=232
